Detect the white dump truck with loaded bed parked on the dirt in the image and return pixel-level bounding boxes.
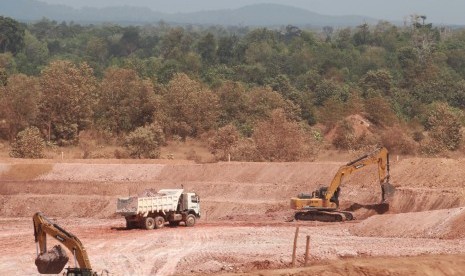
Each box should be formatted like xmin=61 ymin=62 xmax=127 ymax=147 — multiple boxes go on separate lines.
xmin=116 ymin=189 xmax=200 ymax=230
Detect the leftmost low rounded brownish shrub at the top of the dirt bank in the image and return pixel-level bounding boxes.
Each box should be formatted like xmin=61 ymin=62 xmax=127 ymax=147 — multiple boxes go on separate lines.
xmin=10 ymin=127 xmax=45 ymax=158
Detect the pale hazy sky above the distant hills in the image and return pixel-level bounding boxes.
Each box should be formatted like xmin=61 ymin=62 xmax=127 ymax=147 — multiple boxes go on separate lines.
xmin=40 ymin=0 xmax=465 ymax=25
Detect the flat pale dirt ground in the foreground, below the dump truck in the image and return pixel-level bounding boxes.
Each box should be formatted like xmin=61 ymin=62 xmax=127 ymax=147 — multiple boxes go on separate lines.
xmin=0 ymin=219 xmax=465 ymax=275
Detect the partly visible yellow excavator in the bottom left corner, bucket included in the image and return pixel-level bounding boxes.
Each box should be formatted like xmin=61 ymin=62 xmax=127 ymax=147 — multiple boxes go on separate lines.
xmin=32 ymin=212 xmax=102 ymax=276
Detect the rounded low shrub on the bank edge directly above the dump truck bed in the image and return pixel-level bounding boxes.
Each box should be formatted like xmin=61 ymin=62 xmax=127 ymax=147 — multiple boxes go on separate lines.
xmin=124 ymin=124 xmax=165 ymax=159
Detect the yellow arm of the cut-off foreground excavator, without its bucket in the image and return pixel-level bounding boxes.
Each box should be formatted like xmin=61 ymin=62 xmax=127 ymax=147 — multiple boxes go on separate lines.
xmin=32 ymin=212 xmax=92 ymax=275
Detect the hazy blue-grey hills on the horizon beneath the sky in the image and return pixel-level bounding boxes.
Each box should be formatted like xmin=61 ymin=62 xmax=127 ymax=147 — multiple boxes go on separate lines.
xmin=0 ymin=0 xmax=377 ymax=27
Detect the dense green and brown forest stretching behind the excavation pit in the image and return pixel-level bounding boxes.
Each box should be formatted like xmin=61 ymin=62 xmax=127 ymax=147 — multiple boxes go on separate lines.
xmin=0 ymin=15 xmax=465 ymax=161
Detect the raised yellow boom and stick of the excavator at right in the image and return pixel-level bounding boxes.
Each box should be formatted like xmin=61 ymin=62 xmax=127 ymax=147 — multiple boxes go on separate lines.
xmin=325 ymin=147 xmax=390 ymax=202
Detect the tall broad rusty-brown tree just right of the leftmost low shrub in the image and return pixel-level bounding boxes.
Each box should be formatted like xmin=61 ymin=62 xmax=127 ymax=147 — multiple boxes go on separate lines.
xmin=39 ymin=60 xmax=96 ymax=145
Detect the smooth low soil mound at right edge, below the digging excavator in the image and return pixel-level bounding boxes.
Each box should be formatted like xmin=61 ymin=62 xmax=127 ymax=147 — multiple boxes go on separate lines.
xmin=351 ymin=207 xmax=465 ymax=239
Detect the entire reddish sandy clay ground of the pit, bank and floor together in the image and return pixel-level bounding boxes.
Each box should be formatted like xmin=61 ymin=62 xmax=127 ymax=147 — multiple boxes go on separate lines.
xmin=0 ymin=158 xmax=465 ymax=275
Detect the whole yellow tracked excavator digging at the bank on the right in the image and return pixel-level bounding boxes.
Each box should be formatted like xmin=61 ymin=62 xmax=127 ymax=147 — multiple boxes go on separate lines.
xmin=291 ymin=147 xmax=395 ymax=221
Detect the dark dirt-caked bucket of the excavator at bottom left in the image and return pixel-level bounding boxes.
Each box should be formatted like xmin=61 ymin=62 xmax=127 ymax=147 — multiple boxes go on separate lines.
xmin=35 ymin=245 xmax=69 ymax=274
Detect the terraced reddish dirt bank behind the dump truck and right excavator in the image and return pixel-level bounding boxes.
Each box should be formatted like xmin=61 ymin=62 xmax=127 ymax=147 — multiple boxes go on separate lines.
xmin=0 ymin=158 xmax=465 ymax=220
